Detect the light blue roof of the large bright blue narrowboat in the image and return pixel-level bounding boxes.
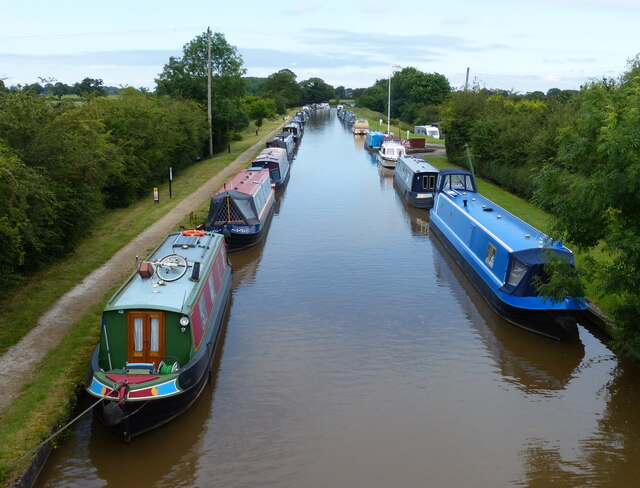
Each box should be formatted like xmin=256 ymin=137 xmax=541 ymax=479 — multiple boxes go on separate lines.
xmin=440 ymin=180 xmax=571 ymax=252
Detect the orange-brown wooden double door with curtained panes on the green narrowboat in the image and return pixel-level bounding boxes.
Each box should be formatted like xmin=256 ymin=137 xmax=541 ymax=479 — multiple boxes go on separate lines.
xmin=127 ymin=312 xmax=164 ymax=365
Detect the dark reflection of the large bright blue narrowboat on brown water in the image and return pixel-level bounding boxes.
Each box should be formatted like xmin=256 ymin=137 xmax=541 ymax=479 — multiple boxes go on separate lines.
xmin=431 ymin=231 xmax=585 ymax=395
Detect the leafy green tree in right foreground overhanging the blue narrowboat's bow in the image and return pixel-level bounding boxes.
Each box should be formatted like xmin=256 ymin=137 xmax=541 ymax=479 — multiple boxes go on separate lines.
xmin=536 ymin=62 xmax=640 ymax=358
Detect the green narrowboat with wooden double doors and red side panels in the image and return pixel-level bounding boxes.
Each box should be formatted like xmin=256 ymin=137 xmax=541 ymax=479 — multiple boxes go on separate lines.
xmin=85 ymin=230 xmax=231 ymax=441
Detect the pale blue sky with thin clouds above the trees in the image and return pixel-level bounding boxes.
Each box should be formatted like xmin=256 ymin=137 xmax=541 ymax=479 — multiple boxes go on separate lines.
xmin=0 ymin=0 xmax=640 ymax=93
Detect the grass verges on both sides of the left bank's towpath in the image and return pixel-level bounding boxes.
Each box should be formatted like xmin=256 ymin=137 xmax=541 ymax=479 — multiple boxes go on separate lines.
xmin=0 ymin=114 xmax=292 ymax=486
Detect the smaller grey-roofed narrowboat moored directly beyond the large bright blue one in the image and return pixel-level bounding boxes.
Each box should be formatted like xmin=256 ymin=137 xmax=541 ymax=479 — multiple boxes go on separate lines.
xmin=393 ymin=156 xmax=438 ymax=208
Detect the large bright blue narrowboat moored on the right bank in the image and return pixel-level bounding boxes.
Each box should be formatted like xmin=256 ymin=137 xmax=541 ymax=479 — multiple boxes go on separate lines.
xmin=429 ymin=169 xmax=587 ymax=340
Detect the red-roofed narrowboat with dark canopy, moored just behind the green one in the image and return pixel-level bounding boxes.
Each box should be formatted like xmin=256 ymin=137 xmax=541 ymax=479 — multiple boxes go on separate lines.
xmin=204 ymin=168 xmax=275 ymax=251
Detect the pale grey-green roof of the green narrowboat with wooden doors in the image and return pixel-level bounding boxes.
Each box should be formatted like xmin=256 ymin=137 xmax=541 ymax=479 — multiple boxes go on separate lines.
xmin=104 ymin=232 xmax=224 ymax=313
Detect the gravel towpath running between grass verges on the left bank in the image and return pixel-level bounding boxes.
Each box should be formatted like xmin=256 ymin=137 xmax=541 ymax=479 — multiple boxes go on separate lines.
xmin=0 ymin=128 xmax=280 ymax=413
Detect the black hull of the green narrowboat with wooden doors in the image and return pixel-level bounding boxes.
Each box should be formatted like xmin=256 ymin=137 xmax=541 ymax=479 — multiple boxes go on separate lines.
xmin=87 ymin=268 xmax=231 ymax=441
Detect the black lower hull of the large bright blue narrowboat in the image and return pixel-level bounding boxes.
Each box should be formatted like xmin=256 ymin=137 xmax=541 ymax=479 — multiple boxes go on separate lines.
xmin=429 ymin=215 xmax=577 ymax=340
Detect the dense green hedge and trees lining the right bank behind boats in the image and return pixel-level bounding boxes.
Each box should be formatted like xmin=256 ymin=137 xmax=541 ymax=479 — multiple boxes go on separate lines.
xmin=441 ymin=57 xmax=640 ymax=358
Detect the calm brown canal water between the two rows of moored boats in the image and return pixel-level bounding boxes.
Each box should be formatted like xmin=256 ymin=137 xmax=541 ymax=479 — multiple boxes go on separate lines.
xmin=37 ymin=110 xmax=640 ymax=488
